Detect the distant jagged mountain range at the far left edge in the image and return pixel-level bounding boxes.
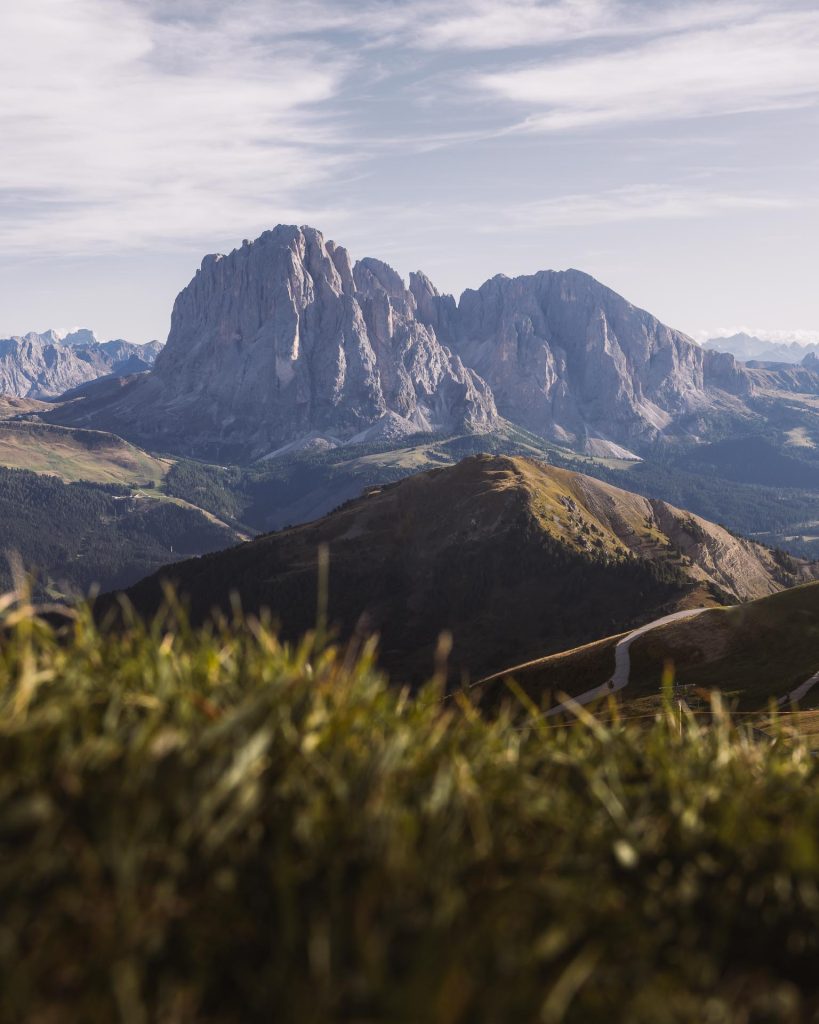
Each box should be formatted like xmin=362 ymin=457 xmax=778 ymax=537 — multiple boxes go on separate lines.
xmin=0 ymin=330 xmax=162 ymax=398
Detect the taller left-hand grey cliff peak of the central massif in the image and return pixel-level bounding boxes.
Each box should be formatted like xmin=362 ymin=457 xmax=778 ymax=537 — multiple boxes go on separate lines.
xmin=109 ymin=226 xmax=498 ymax=456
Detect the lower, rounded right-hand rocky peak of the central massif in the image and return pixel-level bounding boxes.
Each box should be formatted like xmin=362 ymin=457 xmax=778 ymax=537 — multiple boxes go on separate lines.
xmin=421 ymin=270 xmax=747 ymax=442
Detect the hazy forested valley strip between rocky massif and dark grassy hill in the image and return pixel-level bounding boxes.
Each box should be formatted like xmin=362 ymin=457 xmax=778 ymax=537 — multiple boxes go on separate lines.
xmin=165 ymin=428 xmax=819 ymax=558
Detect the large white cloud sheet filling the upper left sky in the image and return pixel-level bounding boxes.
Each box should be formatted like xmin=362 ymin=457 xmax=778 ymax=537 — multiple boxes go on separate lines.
xmin=0 ymin=0 xmax=351 ymax=249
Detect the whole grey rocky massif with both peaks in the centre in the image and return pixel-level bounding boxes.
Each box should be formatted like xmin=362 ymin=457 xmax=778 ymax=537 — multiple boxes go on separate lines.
xmin=44 ymin=226 xmax=798 ymax=460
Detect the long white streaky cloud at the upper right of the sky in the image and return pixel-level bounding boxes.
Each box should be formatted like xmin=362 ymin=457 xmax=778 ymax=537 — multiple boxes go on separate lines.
xmin=477 ymin=10 xmax=819 ymax=131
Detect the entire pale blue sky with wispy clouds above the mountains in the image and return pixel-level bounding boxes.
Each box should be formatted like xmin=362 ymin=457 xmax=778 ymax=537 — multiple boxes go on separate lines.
xmin=0 ymin=0 xmax=819 ymax=341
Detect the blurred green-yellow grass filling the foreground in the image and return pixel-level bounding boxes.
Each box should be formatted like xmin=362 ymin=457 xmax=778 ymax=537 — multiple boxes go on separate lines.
xmin=0 ymin=596 xmax=819 ymax=1024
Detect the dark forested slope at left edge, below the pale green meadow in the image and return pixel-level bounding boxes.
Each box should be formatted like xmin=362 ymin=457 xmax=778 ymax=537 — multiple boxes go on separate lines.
xmin=0 ymin=467 xmax=234 ymax=597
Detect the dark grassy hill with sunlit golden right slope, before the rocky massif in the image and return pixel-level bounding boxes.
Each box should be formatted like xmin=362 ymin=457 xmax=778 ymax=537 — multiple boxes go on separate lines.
xmin=115 ymin=456 xmax=819 ymax=679
